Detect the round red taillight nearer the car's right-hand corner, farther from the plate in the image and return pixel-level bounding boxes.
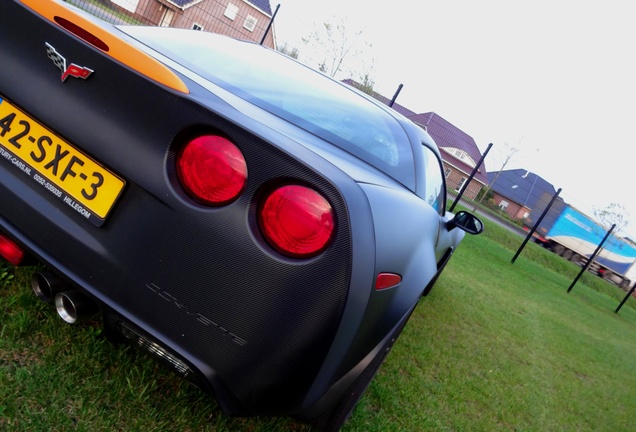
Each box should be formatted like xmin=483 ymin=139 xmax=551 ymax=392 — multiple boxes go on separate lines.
xmin=259 ymin=185 xmax=335 ymax=258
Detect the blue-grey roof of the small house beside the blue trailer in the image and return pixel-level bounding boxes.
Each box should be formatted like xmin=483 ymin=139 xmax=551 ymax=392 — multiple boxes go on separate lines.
xmin=488 ymin=169 xmax=556 ymax=212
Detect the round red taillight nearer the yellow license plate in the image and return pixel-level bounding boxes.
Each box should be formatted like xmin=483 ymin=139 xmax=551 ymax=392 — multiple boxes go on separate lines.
xmin=177 ymin=135 xmax=247 ymax=205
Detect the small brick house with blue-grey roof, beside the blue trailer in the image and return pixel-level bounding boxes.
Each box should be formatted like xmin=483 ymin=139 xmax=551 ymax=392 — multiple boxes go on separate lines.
xmin=488 ymin=169 xmax=556 ymax=220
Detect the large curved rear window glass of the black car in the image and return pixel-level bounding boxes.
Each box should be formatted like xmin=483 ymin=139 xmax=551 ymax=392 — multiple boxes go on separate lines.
xmin=121 ymin=27 xmax=414 ymax=186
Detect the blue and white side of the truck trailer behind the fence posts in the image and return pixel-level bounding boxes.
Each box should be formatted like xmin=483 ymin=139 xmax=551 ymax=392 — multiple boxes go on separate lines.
xmin=547 ymin=206 xmax=636 ymax=275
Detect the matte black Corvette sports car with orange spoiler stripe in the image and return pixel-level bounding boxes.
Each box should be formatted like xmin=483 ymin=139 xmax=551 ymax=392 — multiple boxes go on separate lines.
xmin=0 ymin=0 xmax=482 ymax=430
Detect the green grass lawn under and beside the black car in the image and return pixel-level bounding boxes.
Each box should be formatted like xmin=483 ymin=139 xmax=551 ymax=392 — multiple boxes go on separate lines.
xmin=0 ymin=218 xmax=636 ymax=432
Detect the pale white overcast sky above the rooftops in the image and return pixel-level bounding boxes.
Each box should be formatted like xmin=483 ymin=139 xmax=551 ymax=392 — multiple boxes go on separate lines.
xmin=270 ymin=0 xmax=636 ymax=238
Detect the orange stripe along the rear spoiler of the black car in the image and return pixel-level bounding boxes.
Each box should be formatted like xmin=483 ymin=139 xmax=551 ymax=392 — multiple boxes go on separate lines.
xmin=20 ymin=0 xmax=190 ymax=94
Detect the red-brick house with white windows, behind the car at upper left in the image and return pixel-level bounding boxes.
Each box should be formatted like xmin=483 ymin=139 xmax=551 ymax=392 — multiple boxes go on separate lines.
xmin=111 ymin=0 xmax=276 ymax=48
